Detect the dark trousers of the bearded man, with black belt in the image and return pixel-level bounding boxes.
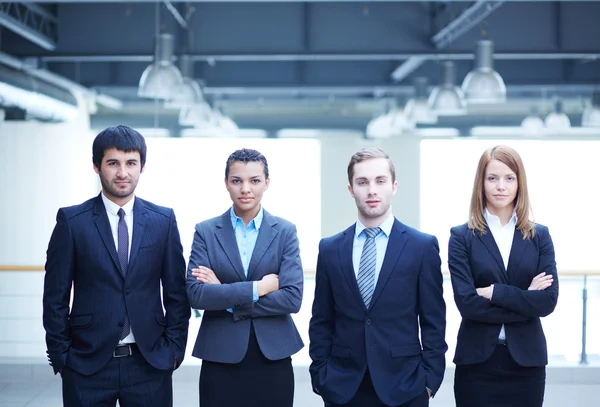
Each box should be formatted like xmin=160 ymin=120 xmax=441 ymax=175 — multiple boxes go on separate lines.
xmin=61 ymin=346 xmax=173 ymax=407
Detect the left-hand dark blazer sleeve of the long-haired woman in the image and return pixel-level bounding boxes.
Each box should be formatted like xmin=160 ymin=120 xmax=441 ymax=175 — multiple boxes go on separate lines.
xmin=448 ymin=228 xmax=531 ymax=324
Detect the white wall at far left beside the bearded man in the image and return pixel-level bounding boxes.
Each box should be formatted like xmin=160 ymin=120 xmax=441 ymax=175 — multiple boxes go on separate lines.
xmin=0 ymin=120 xmax=98 ymax=358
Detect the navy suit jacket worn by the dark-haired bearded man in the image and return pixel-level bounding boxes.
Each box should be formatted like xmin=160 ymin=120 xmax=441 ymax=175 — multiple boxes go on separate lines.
xmin=43 ymin=195 xmax=191 ymax=375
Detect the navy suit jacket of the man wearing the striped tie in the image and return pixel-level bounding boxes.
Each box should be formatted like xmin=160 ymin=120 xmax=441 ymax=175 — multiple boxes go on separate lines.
xmin=309 ymin=220 xmax=448 ymax=406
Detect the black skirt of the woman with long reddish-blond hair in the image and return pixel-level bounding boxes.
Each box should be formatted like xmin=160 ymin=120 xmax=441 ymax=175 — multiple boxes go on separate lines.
xmin=454 ymin=345 xmax=546 ymax=407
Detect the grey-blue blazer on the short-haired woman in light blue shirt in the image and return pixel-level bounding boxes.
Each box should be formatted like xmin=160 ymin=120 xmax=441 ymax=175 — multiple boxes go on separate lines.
xmin=187 ymin=210 xmax=304 ymax=363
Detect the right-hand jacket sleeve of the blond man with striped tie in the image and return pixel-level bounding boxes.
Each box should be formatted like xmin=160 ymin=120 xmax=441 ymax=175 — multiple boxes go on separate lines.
xmin=418 ymin=236 xmax=448 ymax=394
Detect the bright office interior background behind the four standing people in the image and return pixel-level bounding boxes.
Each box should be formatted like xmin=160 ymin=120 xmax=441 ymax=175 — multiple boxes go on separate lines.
xmin=0 ymin=0 xmax=600 ymax=406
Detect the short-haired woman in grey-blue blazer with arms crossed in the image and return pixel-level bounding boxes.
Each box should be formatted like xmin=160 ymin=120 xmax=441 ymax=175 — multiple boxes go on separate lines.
xmin=187 ymin=149 xmax=304 ymax=407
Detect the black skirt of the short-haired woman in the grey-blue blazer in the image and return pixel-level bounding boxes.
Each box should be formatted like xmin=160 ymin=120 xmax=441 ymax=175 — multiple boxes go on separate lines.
xmin=200 ymin=327 xmax=294 ymax=407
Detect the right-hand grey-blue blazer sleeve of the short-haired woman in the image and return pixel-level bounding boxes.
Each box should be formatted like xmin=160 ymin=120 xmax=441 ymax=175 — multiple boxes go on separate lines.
xmin=233 ymin=226 xmax=304 ymax=321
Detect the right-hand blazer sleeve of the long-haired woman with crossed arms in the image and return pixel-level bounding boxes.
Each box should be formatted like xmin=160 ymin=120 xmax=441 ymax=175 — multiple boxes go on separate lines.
xmin=491 ymin=228 xmax=558 ymax=318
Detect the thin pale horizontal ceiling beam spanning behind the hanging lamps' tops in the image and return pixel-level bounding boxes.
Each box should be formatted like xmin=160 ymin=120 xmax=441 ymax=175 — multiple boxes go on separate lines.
xmin=38 ymin=51 xmax=600 ymax=64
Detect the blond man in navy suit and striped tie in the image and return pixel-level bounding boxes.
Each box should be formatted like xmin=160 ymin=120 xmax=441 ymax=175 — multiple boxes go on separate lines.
xmin=309 ymin=148 xmax=448 ymax=407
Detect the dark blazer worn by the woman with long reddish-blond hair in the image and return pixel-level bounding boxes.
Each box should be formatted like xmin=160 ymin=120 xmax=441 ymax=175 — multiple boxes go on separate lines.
xmin=448 ymin=224 xmax=558 ymax=366
